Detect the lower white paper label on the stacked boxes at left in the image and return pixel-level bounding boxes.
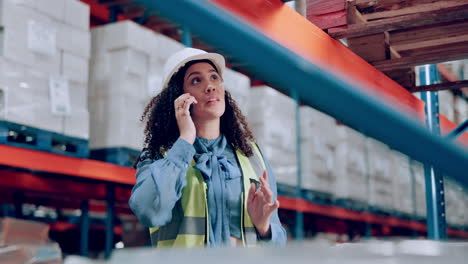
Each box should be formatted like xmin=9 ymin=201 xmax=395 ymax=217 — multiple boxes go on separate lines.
xmin=49 ymin=75 xmax=71 ymax=116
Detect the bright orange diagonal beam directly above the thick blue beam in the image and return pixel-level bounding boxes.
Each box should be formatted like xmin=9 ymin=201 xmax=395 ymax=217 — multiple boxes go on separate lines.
xmin=210 ymin=0 xmax=468 ymax=146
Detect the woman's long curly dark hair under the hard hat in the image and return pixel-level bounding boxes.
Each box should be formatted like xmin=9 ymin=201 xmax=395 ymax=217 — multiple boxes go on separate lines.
xmin=135 ymin=60 xmax=255 ymax=165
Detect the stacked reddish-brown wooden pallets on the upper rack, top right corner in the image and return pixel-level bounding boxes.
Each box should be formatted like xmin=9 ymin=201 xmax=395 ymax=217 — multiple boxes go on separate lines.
xmin=307 ymin=0 xmax=468 ymax=92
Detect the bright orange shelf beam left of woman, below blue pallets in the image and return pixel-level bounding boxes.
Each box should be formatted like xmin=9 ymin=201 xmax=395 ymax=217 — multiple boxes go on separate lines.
xmin=0 ymin=145 xmax=135 ymax=188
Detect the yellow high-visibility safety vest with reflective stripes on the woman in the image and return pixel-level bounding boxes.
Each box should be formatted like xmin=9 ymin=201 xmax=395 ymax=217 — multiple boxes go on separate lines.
xmin=149 ymin=144 xmax=265 ymax=248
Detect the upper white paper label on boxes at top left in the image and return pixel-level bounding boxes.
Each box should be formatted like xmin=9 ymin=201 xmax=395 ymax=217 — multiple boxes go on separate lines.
xmin=28 ymin=20 xmax=57 ymax=56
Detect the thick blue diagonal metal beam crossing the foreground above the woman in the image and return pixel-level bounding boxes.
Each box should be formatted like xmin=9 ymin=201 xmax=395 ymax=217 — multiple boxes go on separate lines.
xmin=132 ymin=0 xmax=468 ymax=186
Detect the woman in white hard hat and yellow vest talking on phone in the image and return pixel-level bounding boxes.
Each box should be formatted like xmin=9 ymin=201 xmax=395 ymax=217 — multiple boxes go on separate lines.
xmin=129 ymin=48 xmax=286 ymax=247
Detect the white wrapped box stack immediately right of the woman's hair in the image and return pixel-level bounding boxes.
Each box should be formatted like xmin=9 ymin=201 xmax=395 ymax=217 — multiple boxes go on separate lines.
xmin=247 ymin=86 xmax=297 ymax=190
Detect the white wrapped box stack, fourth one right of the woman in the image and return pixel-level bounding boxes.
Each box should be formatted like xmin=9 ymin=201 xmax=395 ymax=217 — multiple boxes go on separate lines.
xmin=366 ymin=138 xmax=393 ymax=210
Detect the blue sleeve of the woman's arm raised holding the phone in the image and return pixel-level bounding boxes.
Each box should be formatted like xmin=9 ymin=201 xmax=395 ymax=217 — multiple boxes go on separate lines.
xmin=128 ymin=138 xmax=195 ymax=227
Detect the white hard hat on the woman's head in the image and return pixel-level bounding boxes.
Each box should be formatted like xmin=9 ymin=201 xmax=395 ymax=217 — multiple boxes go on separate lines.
xmin=162 ymin=48 xmax=226 ymax=89
